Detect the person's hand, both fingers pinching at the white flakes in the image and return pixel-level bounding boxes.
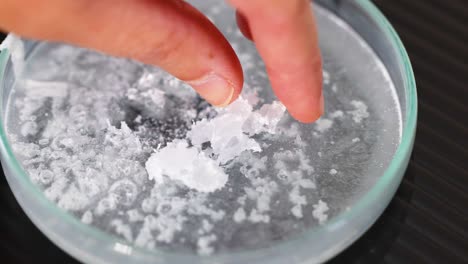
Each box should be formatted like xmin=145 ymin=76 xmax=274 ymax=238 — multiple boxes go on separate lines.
xmin=0 ymin=0 xmax=323 ymax=123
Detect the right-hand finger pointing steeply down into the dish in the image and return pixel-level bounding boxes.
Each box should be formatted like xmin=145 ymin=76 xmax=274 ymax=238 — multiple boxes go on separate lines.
xmin=230 ymin=0 xmax=323 ymax=122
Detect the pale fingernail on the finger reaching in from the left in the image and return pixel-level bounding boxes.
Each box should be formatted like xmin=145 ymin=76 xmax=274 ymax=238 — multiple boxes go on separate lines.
xmin=187 ymin=73 xmax=234 ymax=107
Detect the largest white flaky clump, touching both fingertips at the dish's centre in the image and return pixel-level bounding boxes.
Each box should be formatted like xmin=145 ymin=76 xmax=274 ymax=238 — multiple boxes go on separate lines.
xmin=146 ymin=96 xmax=285 ymax=192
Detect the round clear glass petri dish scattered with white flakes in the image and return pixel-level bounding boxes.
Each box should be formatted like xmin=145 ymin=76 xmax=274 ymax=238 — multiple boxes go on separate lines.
xmin=0 ymin=1 xmax=417 ymax=263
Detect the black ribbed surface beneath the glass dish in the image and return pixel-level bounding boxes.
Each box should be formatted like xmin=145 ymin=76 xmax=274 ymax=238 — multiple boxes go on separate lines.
xmin=0 ymin=0 xmax=468 ymax=264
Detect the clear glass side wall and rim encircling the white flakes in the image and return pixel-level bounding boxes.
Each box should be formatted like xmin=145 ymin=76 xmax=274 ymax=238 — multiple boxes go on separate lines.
xmin=0 ymin=0 xmax=417 ymax=263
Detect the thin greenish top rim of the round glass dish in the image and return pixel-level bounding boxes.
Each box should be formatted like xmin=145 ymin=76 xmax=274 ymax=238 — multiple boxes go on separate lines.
xmin=0 ymin=0 xmax=417 ymax=262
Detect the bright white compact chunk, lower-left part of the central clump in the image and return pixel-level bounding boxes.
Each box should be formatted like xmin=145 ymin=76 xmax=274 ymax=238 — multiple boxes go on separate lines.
xmin=146 ymin=140 xmax=228 ymax=192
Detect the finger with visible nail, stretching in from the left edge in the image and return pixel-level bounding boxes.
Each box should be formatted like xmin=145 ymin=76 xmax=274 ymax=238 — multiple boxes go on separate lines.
xmin=0 ymin=0 xmax=243 ymax=105
